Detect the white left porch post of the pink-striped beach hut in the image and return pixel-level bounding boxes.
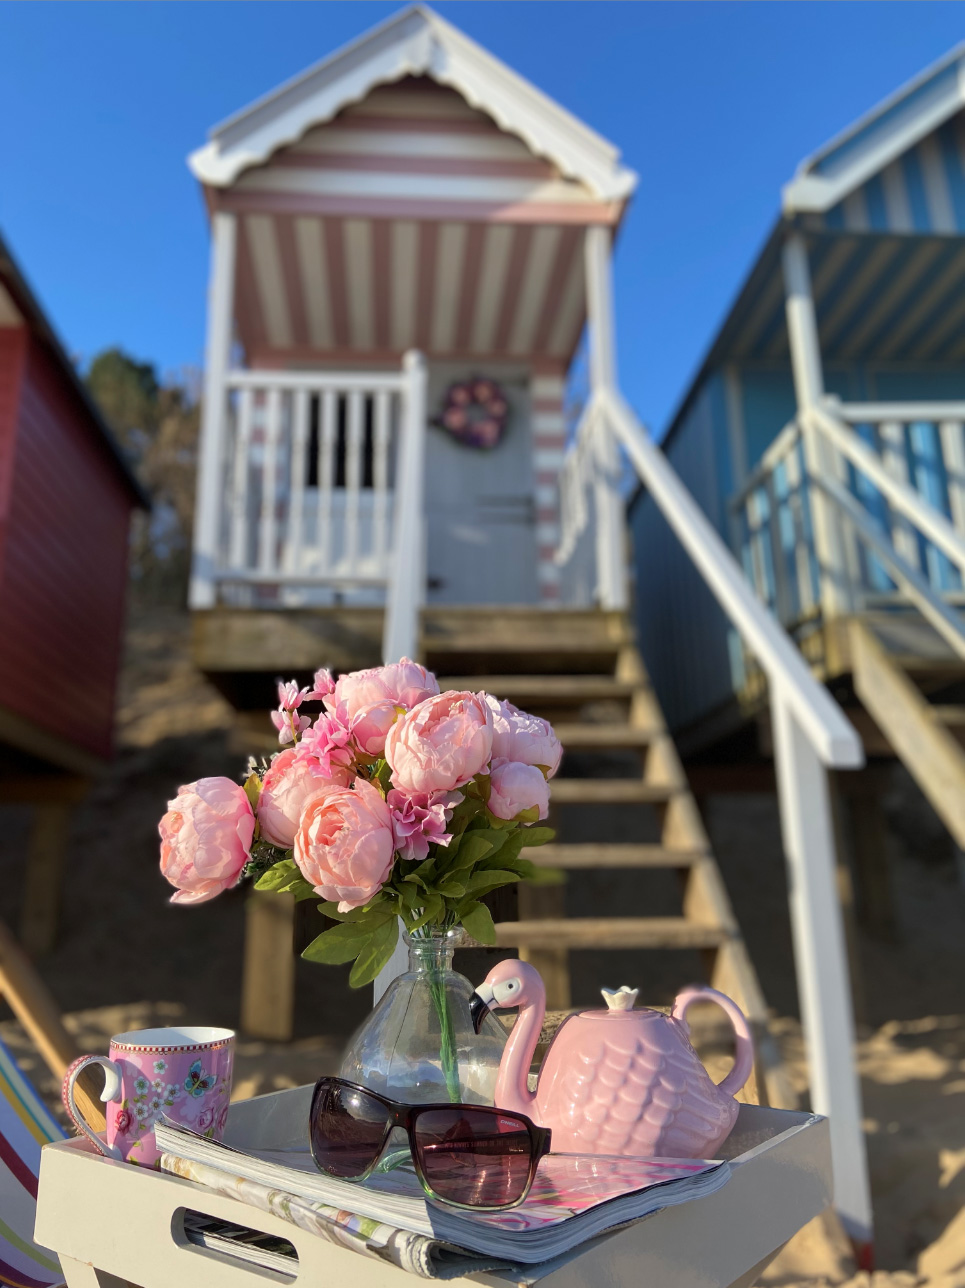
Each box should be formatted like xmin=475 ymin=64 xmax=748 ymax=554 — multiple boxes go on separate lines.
xmin=188 ymin=210 xmax=237 ymax=608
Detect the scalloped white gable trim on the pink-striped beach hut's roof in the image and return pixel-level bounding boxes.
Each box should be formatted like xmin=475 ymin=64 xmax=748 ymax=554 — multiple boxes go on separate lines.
xmin=189 ymin=5 xmax=636 ymax=201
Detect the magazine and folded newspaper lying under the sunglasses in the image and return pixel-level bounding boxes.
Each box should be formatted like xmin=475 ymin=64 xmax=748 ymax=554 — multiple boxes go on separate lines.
xmin=157 ymin=1122 xmax=729 ymax=1276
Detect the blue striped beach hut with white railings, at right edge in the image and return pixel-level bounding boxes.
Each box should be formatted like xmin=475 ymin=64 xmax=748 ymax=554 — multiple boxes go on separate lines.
xmin=631 ymin=45 xmax=965 ymax=846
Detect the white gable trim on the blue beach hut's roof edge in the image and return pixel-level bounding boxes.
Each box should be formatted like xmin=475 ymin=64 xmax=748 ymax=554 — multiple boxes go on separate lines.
xmin=782 ymin=43 xmax=965 ymax=215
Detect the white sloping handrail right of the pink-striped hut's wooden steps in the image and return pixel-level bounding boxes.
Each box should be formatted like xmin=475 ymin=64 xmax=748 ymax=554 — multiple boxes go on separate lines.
xmin=595 ymin=390 xmax=865 ymax=769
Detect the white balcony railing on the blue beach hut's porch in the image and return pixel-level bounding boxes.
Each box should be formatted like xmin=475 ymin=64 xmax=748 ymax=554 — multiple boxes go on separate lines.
xmin=731 ymin=398 xmax=965 ymax=656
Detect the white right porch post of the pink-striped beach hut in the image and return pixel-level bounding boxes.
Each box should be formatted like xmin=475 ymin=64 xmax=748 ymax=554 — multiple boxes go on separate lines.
xmin=584 ymin=224 xmax=627 ymax=609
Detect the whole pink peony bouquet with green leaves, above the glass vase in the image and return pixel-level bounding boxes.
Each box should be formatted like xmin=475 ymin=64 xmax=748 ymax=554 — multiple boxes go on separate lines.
xmin=158 ymin=658 xmax=563 ymax=988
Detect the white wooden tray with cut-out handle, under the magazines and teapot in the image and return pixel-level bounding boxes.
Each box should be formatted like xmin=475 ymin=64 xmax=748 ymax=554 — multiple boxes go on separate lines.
xmin=36 ymin=1087 xmax=831 ymax=1288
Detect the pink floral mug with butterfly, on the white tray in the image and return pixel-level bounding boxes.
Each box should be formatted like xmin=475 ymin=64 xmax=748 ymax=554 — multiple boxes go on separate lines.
xmin=62 ymin=1027 xmax=234 ymax=1167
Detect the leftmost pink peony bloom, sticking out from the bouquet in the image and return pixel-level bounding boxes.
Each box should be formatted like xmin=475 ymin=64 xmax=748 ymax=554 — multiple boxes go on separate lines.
xmin=157 ymin=778 xmax=255 ymax=903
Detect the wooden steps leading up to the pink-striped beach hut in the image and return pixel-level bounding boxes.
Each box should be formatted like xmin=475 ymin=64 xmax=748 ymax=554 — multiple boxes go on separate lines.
xmin=423 ymin=608 xmax=790 ymax=1104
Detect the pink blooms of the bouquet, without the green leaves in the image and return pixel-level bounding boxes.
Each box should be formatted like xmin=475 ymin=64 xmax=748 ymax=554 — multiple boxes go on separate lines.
xmin=160 ymin=658 xmax=563 ymax=912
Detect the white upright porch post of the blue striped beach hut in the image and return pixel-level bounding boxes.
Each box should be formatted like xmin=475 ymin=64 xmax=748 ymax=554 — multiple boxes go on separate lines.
xmin=782 ymin=233 xmax=852 ymax=620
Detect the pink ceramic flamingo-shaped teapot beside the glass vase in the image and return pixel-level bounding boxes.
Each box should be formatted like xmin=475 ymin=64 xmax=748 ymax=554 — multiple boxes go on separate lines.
xmin=472 ymin=961 xmax=754 ymax=1158
